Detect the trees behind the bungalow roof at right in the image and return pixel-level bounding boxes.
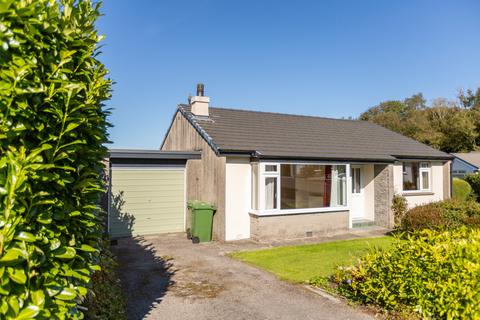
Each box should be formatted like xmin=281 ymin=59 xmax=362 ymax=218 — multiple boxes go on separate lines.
xmin=360 ymin=87 xmax=480 ymax=152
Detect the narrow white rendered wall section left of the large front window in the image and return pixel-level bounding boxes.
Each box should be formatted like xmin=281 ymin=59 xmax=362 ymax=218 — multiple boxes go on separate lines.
xmin=225 ymin=157 xmax=252 ymax=241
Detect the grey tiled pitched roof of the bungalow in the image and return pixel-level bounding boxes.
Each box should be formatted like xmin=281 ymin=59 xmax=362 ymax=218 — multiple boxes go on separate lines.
xmin=179 ymin=105 xmax=451 ymax=162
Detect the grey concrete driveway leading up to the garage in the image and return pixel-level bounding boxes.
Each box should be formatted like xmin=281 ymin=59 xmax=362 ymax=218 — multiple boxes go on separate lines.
xmin=113 ymin=234 xmax=371 ymax=320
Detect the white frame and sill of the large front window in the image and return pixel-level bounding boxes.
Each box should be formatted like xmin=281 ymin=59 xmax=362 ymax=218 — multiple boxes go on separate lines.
xmin=255 ymin=162 xmax=351 ymax=215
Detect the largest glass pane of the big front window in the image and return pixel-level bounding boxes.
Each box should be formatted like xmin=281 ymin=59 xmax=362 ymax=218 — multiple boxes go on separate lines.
xmin=280 ymin=164 xmax=346 ymax=209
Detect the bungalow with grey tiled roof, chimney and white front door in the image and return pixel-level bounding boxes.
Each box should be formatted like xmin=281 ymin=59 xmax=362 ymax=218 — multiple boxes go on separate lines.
xmin=160 ymin=85 xmax=452 ymax=241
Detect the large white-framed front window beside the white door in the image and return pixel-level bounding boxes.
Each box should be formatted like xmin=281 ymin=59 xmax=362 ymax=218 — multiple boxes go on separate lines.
xmin=252 ymin=163 xmax=347 ymax=211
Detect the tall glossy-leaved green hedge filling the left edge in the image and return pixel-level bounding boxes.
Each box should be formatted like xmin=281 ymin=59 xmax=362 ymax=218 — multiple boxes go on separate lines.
xmin=0 ymin=0 xmax=111 ymax=319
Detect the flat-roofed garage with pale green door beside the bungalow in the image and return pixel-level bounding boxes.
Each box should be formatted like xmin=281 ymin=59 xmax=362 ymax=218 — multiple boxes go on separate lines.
xmin=108 ymin=149 xmax=200 ymax=238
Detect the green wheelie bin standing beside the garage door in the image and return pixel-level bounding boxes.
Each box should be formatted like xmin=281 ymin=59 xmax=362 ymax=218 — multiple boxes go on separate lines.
xmin=187 ymin=200 xmax=215 ymax=243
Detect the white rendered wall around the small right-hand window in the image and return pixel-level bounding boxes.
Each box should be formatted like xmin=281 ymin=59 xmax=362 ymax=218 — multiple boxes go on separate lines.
xmin=393 ymin=161 xmax=449 ymax=208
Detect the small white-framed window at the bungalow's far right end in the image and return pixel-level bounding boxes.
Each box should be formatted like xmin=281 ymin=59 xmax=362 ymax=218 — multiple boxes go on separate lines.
xmin=403 ymin=162 xmax=431 ymax=191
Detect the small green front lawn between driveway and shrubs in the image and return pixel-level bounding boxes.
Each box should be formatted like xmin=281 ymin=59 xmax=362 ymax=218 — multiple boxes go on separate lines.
xmin=230 ymin=237 xmax=393 ymax=282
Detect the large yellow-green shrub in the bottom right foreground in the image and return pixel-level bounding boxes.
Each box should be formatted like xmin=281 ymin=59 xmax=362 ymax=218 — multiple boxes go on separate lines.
xmin=332 ymin=228 xmax=480 ymax=319
